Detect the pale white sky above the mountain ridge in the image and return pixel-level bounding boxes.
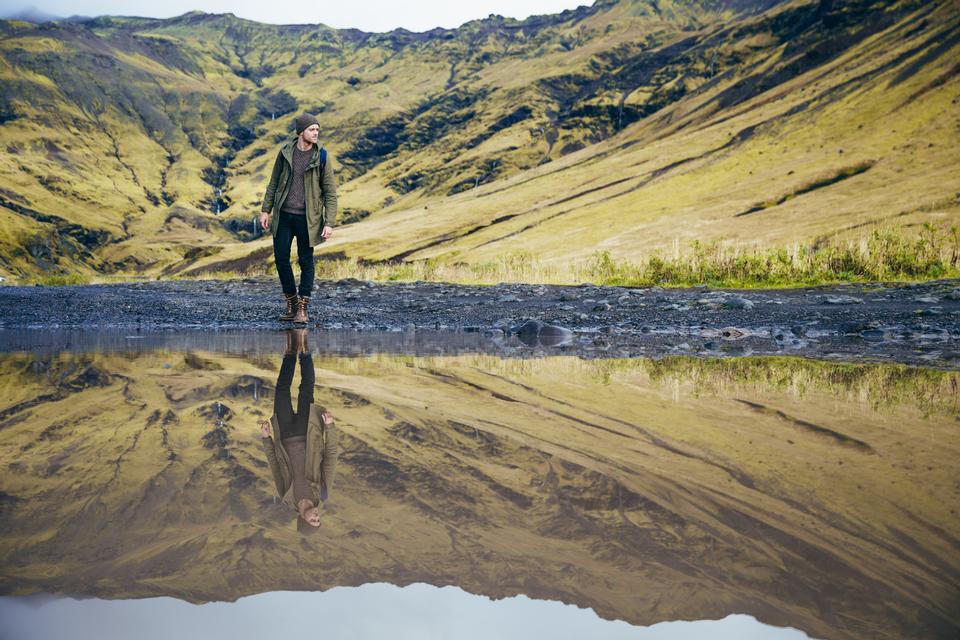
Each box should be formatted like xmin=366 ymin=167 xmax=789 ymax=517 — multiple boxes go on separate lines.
xmin=0 ymin=0 xmax=593 ymax=32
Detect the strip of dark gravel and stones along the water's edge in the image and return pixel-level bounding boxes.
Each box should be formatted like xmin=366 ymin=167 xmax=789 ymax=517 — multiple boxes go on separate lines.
xmin=0 ymin=278 xmax=960 ymax=368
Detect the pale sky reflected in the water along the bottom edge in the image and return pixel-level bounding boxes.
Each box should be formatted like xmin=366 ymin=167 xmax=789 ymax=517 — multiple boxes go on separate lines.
xmin=0 ymin=583 xmax=807 ymax=640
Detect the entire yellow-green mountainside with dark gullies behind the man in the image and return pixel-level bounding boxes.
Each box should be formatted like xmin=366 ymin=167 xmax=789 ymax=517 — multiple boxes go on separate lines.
xmin=0 ymin=0 xmax=960 ymax=276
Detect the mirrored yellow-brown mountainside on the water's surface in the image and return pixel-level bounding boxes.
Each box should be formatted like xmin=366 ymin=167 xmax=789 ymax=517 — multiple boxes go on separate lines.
xmin=0 ymin=352 xmax=960 ymax=638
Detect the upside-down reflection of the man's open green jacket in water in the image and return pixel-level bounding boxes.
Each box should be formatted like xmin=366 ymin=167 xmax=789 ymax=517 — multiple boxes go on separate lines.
xmin=261 ymin=404 xmax=340 ymax=508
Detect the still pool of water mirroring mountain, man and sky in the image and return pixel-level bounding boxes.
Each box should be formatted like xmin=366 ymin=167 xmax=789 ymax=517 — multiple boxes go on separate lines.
xmin=0 ymin=334 xmax=960 ymax=638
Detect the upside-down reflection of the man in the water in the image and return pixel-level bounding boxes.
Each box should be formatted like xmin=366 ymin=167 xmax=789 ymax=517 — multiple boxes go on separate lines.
xmin=260 ymin=329 xmax=338 ymax=530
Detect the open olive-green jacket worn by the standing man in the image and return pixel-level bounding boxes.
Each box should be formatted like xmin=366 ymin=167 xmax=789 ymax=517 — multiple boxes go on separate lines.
xmin=260 ymin=138 xmax=337 ymax=247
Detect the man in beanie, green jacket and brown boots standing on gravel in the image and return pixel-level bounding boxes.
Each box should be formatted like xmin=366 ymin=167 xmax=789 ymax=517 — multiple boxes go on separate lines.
xmin=260 ymin=113 xmax=337 ymax=323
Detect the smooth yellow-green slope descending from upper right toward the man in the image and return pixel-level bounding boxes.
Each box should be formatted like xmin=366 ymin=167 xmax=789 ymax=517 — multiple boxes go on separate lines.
xmin=329 ymin=0 xmax=960 ymax=261
